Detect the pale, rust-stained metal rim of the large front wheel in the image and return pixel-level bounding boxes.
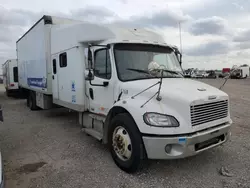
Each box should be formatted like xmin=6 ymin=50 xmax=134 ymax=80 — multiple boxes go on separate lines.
xmin=112 ymin=126 xmax=132 ymax=161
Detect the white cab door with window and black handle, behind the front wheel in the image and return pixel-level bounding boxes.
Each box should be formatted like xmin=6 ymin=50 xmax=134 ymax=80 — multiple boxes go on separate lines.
xmin=86 ymin=48 xmax=114 ymax=115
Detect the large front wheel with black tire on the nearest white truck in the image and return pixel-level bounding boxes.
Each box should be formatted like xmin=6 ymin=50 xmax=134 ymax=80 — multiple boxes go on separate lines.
xmin=108 ymin=113 xmax=145 ymax=173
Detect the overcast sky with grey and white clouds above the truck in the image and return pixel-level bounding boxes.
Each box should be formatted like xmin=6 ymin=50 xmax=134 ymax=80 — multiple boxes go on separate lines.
xmin=0 ymin=0 xmax=250 ymax=73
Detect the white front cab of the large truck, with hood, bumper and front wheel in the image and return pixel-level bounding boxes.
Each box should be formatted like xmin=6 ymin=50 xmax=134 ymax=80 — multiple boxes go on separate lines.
xmin=72 ymin=24 xmax=232 ymax=172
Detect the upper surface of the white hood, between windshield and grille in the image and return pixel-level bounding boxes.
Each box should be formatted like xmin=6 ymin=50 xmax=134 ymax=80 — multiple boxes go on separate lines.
xmin=121 ymin=78 xmax=228 ymax=104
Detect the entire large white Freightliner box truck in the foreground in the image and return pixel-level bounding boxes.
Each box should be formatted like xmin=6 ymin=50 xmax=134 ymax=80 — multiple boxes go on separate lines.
xmin=17 ymin=16 xmax=232 ymax=172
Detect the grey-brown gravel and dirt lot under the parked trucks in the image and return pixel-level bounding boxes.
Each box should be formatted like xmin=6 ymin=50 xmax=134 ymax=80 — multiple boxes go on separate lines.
xmin=0 ymin=79 xmax=250 ymax=188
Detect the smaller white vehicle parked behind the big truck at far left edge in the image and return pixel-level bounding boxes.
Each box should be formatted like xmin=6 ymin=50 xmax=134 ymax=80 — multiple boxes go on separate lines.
xmin=2 ymin=59 xmax=19 ymax=96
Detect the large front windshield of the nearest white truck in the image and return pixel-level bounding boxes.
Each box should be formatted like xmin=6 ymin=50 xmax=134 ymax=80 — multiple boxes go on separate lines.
xmin=114 ymin=44 xmax=183 ymax=81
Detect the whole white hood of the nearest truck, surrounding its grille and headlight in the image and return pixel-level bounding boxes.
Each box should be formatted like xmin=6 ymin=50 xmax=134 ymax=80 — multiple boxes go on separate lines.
xmin=119 ymin=78 xmax=230 ymax=134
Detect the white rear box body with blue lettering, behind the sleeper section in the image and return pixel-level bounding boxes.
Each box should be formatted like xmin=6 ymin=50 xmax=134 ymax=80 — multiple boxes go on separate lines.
xmin=16 ymin=15 xmax=84 ymax=109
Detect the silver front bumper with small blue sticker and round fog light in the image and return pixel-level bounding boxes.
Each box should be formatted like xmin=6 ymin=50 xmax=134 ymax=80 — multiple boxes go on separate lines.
xmin=142 ymin=123 xmax=231 ymax=159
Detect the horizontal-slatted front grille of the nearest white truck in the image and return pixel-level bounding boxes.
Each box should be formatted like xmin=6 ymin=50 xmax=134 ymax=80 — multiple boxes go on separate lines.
xmin=190 ymin=100 xmax=228 ymax=126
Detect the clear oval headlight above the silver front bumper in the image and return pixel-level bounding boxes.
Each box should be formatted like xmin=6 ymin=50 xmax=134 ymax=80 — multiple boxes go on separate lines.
xmin=143 ymin=112 xmax=179 ymax=127
